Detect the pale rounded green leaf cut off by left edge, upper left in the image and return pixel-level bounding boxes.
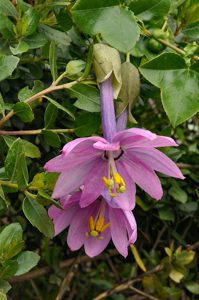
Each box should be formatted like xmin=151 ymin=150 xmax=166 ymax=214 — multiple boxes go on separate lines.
xmin=0 ymin=55 xmax=19 ymax=81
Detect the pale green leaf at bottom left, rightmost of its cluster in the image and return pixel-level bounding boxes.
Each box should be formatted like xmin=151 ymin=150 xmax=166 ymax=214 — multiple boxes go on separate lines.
xmin=14 ymin=251 xmax=40 ymax=276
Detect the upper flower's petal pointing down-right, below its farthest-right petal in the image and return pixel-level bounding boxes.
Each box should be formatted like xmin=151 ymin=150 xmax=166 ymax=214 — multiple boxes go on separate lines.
xmin=124 ymin=154 xmax=163 ymax=200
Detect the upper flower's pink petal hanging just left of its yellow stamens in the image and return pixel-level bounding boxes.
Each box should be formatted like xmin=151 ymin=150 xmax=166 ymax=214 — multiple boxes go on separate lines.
xmin=80 ymin=159 xmax=108 ymax=207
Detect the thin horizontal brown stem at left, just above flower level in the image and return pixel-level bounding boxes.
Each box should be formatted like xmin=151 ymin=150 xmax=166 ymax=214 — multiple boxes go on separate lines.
xmin=0 ymin=128 xmax=75 ymax=135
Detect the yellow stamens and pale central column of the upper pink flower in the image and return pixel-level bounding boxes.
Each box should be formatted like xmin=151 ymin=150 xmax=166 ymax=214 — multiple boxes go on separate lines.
xmin=102 ymin=152 xmax=126 ymax=197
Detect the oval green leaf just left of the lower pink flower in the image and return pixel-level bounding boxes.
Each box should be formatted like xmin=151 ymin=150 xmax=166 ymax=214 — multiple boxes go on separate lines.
xmin=22 ymin=197 xmax=54 ymax=238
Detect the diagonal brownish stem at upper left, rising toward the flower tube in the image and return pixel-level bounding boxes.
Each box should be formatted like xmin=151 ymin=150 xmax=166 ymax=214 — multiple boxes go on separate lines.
xmin=0 ymin=80 xmax=96 ymax=128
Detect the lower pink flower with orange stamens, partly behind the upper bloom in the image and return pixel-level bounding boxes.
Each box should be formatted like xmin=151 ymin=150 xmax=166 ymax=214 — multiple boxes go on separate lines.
xmin=48 ymin=192 xmax=137 ymax=257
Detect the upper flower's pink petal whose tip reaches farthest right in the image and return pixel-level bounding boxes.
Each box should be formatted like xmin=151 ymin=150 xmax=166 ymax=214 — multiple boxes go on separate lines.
xmin=127 ymin=148 xmax=185 ymax=179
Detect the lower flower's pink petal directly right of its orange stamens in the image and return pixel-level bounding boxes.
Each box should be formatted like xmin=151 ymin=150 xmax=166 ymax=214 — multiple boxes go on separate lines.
xmin=109 ymin=208 xmax=129 ymax=257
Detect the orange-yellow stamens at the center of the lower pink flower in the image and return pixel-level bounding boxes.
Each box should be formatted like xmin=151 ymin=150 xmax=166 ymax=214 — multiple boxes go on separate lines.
xmin=86 ymin=209 xmax=111 ymax=240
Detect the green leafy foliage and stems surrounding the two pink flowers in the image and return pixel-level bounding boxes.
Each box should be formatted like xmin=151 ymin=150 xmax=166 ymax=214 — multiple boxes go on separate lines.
xmin=0 ymin=0 xmax=199 ymax=300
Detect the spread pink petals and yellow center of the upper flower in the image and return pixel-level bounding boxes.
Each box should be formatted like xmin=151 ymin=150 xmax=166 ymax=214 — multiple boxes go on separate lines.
xmin=45 ymin=128 xmax=184 ymax=210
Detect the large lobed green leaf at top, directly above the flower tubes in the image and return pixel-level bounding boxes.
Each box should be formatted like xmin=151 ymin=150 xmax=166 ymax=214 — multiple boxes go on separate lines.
xmin=72 ymin=0 xmax=140 ymax=52
